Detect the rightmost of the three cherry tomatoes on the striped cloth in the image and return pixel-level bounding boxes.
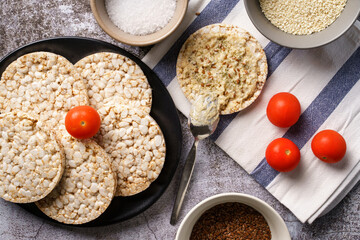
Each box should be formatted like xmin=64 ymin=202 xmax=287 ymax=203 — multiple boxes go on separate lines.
xmin=311 ymin=130 xmax=346 ymax=163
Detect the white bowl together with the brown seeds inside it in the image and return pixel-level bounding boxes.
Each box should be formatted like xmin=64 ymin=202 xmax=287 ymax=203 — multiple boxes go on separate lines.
xmin=175 ymin=193 xmax=291 ymax=240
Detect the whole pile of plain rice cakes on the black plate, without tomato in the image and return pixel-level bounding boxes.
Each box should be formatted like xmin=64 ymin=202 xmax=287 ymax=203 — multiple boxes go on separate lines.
xmin=0 ymin=52 xmax=165 ymax=224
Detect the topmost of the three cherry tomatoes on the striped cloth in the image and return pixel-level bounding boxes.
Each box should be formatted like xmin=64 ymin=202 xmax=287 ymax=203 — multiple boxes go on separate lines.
xmin=266 ymin=92 xmax=301 ymax=128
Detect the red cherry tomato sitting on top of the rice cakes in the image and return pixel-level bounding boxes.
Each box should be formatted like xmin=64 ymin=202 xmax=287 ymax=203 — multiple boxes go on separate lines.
xmin=65 ymin=106 xmax=101 ymax=139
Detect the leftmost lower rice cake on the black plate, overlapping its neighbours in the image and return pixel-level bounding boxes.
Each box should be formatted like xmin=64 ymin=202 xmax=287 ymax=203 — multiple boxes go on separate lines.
xmin=0 ymin=111 xmax=65 ymax=203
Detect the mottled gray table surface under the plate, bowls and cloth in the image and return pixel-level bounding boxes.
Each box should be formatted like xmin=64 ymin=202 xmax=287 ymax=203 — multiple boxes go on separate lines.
xmin=0 ymin=0 xmax=360 ymax=240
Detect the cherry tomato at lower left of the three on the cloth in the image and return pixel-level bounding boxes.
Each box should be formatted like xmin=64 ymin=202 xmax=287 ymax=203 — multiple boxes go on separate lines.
xmin=265 ymin=138 xmax=300 ymax=172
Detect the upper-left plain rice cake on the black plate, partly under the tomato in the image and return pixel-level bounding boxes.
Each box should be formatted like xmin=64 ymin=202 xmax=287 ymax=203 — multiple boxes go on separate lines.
xmin=0 ymin=52 xmax=88 ymax=128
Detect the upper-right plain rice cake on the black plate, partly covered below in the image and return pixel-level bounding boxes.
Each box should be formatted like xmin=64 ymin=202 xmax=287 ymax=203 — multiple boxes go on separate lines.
xmin=75 ymin=52 xmax=152 ymax=113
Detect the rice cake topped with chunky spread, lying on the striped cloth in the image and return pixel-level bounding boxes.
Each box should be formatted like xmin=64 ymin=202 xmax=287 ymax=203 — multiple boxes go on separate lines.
xmin=176 ymin=24 xmax=268 ymax=114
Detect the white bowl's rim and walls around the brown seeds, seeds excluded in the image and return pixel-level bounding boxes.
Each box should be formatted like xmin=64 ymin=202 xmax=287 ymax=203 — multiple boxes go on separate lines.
xmin=175 ymin=193 xmax=291 ymax=240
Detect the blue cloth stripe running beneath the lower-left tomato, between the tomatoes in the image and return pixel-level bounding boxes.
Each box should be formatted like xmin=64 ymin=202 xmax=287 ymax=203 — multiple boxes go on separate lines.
xmin=251 ymin=48 xmax=360 ymax=187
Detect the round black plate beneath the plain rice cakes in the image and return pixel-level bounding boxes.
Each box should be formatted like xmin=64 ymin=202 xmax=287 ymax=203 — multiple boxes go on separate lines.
xmin=0 ymin=37 xmax=182 ymax=226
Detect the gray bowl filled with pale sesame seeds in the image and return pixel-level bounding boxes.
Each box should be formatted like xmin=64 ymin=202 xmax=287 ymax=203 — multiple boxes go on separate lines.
xmin=244 ymin=0 xmax=360 ymax=49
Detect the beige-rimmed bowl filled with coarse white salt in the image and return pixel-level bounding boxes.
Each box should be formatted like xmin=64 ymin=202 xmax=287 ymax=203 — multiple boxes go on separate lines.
xmin=90 ymin=0 xmax=188 ymax=46
